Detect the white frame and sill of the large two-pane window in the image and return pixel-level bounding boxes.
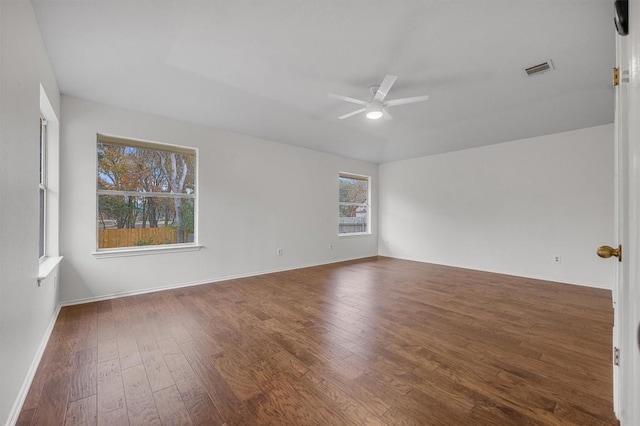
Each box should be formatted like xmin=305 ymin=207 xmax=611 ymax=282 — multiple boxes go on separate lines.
xmin=92 ymin=133 xmax=202 ymax=258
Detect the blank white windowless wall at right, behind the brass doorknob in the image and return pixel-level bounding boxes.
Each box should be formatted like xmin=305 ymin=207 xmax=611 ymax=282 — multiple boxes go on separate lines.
xmin=379 ymin=125 xmax=616 ymax=288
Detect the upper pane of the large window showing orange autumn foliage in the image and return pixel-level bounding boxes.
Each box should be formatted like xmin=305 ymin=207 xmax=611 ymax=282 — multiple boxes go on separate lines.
xmin=98 ymin=142 xmax=196 ymax=194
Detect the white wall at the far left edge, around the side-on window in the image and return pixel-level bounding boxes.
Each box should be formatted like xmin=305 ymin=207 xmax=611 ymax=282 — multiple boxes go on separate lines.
xmin=0 ymin=1 xmax=59 ymax=424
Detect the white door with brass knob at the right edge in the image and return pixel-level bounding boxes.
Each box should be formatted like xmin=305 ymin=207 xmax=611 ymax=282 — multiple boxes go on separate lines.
xmin=613 ymin=0 xmax=640 ymax=426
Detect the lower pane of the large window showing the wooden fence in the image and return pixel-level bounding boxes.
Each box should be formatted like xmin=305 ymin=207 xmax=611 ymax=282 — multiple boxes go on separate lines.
xmin=97 ymin=195 xmax=195 ymax=249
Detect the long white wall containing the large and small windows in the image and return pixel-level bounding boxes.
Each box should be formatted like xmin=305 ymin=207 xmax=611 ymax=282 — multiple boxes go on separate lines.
xmin=60 ymin=96 xmax=378 ymax=302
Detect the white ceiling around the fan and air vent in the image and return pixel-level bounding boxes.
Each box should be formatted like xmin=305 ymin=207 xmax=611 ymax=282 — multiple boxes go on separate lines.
xmin=32 ymin=0 xmax=615 ymax=162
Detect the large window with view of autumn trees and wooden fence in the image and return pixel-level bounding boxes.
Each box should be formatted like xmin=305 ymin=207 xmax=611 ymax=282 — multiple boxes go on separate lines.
xmin=97 ymin=135 xmax=197 ymax=249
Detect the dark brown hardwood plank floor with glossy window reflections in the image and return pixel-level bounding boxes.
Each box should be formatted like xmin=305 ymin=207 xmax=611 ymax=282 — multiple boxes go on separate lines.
xmin=18 ymin=258 xmax=617 ymax=426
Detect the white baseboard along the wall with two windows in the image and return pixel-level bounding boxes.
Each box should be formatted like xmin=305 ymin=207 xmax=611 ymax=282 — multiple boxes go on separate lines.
xmin=60 ymin=255 xmax=377 ymax=306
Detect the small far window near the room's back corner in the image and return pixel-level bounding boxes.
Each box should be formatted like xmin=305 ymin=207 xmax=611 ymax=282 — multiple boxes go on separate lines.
xmin=338 ymin=173 xmax=370 ymax=235
